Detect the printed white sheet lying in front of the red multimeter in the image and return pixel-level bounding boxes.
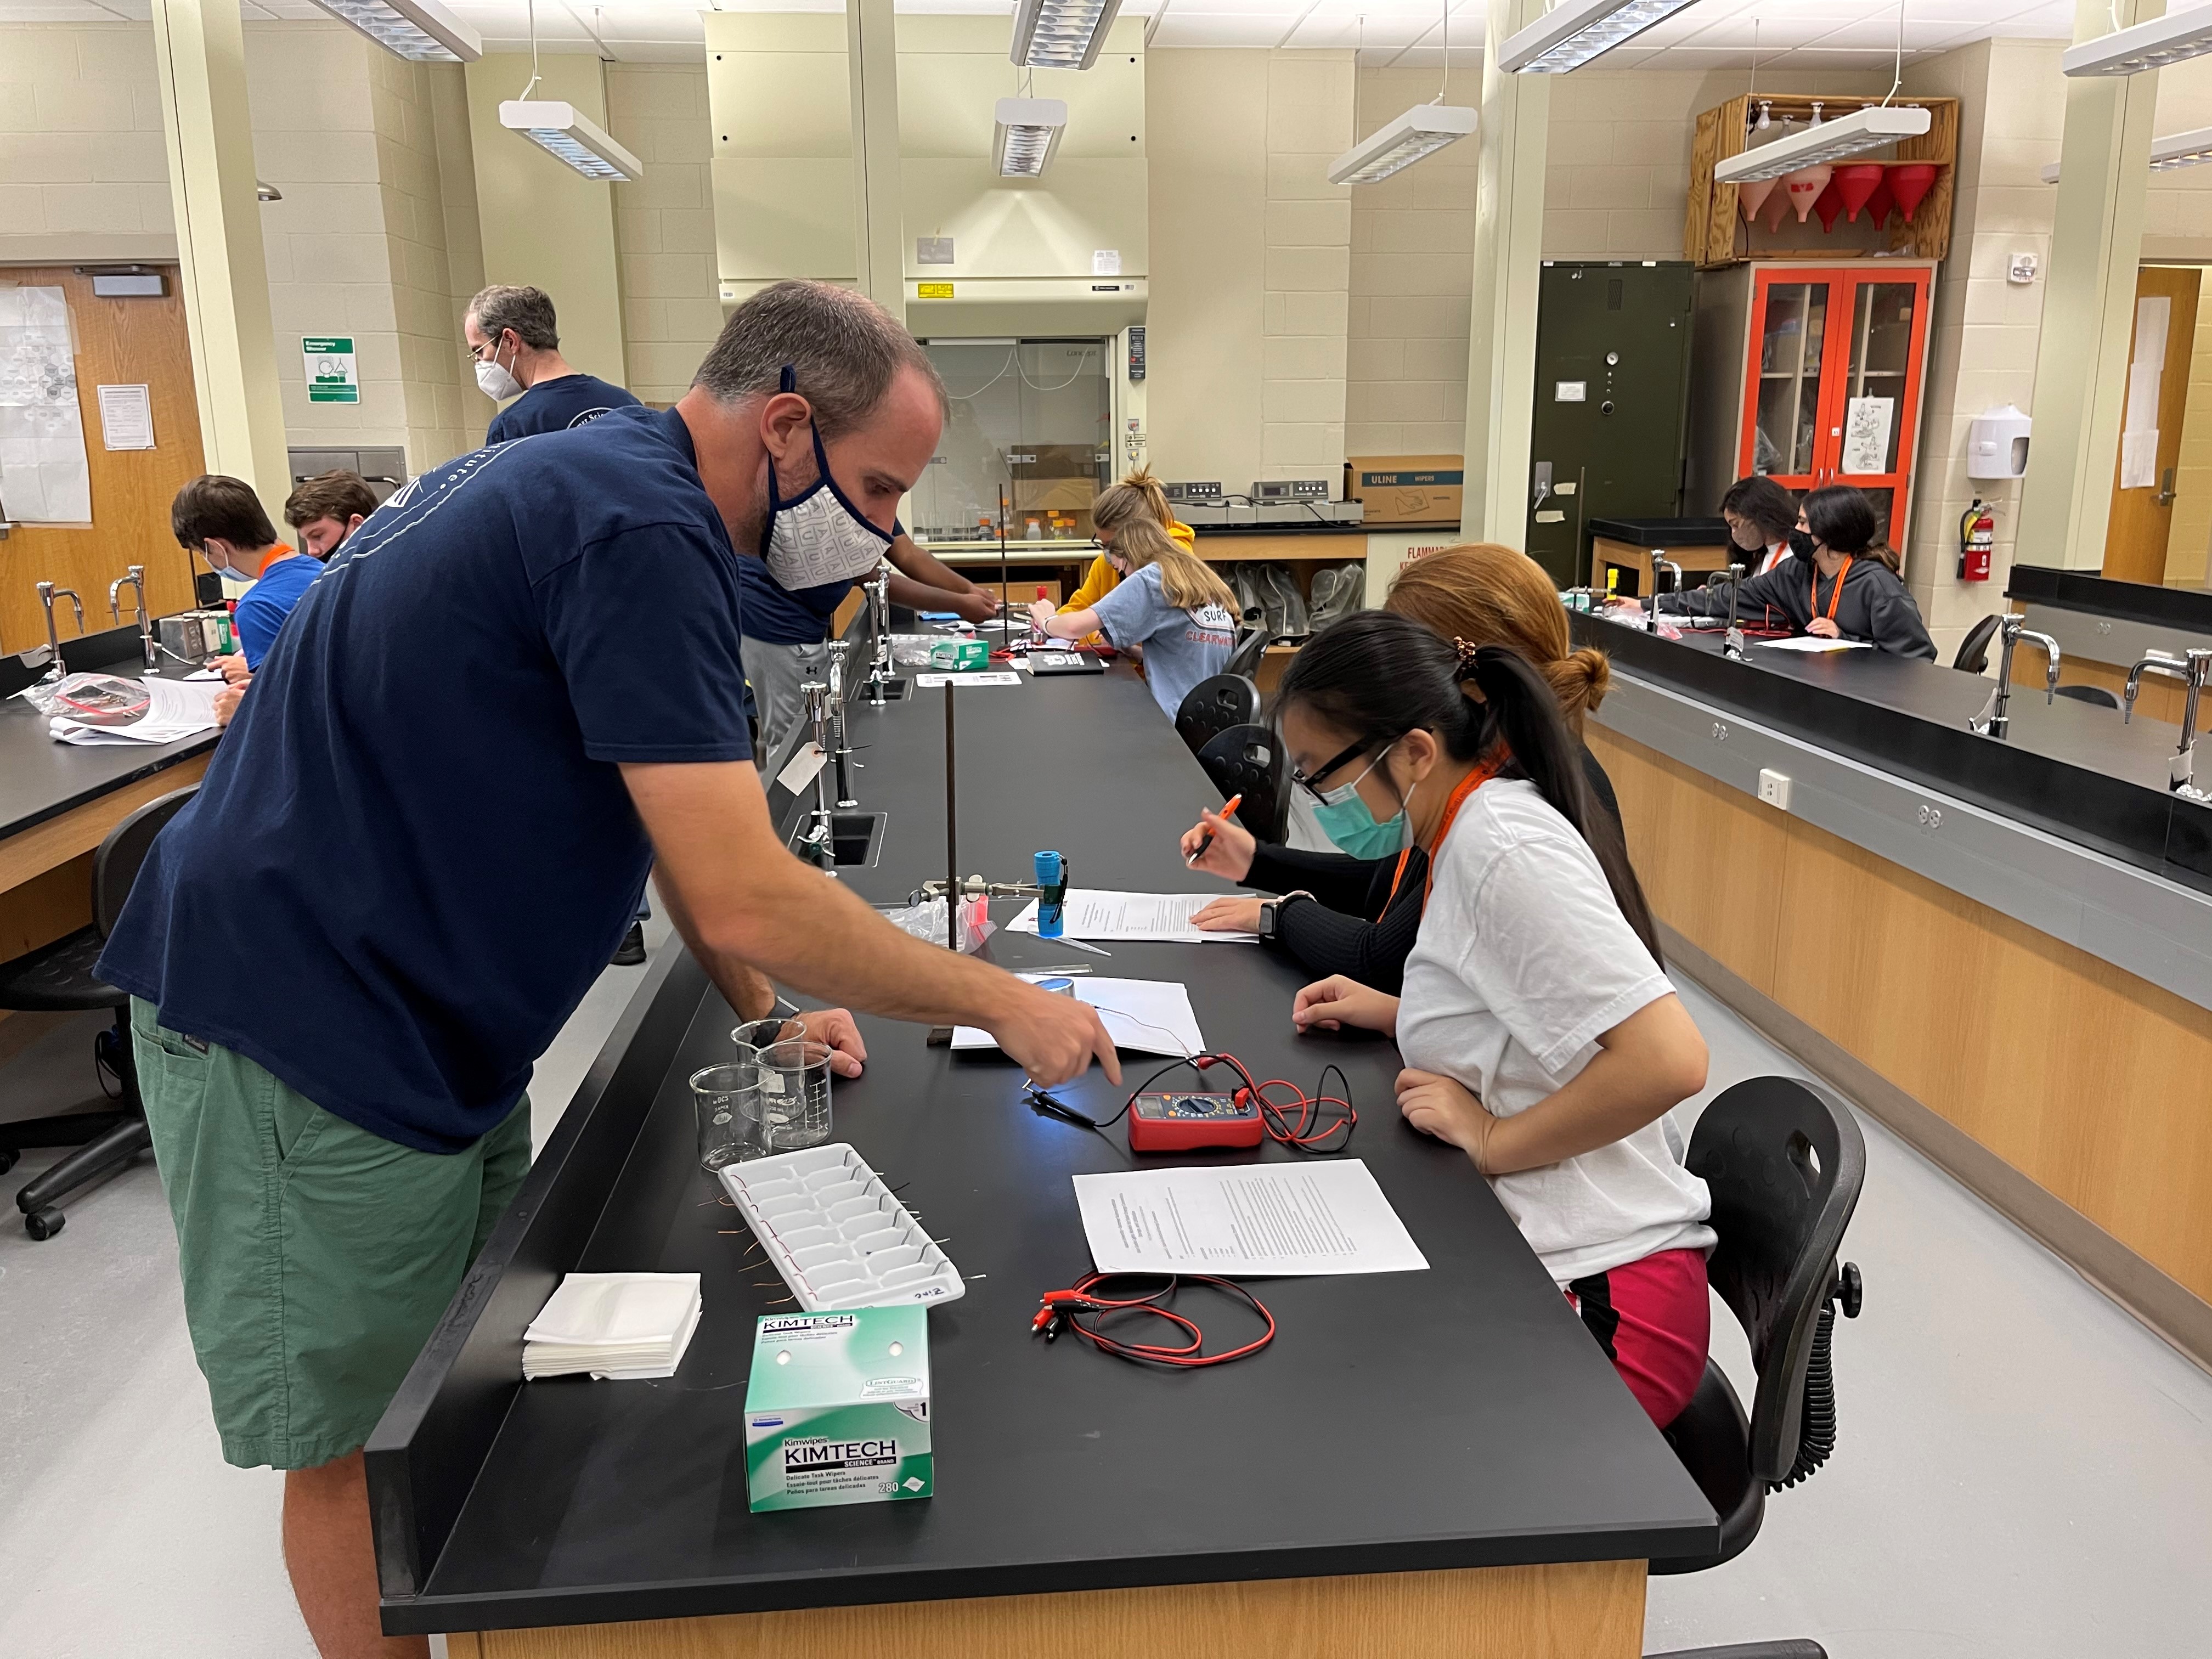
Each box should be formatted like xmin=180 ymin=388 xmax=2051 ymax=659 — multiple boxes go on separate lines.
xmin=1073 ymin=1157 xmax=1429 ymax=1276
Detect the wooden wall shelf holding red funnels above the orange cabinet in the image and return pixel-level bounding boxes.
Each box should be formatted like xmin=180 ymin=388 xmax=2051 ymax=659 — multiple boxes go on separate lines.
xmin=1681 ymin=93 xmax=1957 ymax=270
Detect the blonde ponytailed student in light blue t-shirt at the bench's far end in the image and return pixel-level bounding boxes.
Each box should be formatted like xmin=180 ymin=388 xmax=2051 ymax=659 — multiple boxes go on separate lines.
xmin=1029 ymin=520 xmax=1237 ymax=721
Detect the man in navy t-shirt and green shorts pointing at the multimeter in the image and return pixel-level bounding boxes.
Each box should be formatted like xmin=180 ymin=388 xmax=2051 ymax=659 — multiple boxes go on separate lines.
xmin=99 ymin=283 xmax=1119 ymax=1652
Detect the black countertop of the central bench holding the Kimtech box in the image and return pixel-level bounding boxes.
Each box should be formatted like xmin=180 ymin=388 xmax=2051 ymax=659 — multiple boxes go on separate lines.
xmin=369 ymin=666 xmax=1714 ymax=1633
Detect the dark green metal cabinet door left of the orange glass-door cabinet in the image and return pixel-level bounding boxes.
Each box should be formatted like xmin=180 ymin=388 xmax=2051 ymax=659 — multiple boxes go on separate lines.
xmin=1526 ymin=261 xmax=1697 ymax=589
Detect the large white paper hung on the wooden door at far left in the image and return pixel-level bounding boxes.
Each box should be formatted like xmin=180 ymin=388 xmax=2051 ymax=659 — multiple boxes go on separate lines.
xmin=0 ymin=287 xmax=93 ymax=524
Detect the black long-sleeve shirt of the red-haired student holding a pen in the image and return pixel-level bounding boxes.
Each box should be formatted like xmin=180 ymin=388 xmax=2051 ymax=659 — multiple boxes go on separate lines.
xmin=1245 ymin=748 xmax=1621 ymax=995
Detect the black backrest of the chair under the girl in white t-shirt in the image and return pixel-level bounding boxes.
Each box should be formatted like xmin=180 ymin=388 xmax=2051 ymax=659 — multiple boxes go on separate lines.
xmin=1688 ymin=1077 xmax=1867 ymax=1484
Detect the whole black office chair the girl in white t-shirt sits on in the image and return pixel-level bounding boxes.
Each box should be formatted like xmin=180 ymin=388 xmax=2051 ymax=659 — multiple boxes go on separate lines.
xmin=1650 ymin=1077 xmax=1867 ymax=1659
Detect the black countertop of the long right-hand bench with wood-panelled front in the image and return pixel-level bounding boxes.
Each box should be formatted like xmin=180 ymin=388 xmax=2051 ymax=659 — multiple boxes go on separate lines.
xmin=1571 ymin=613 xmax=2212 ymax=891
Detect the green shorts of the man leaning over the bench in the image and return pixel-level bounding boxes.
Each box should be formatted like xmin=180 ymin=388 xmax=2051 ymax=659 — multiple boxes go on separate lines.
xmin=131 ymin=997 xmax=531 ymax=1469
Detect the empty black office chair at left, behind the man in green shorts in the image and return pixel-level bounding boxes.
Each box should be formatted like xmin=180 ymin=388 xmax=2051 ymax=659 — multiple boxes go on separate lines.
xmin=0 ymin=783 xmax=199 ymax=1239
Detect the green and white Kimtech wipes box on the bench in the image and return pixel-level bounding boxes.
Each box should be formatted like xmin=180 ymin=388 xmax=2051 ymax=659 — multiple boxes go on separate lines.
xmin=746 ymin=1305 xmax=936 ymax=1511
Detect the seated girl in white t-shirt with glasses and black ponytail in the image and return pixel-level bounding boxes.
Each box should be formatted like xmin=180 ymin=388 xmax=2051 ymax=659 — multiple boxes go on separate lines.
xmin=1278 ymin=611 xmax=1714 ymax=1427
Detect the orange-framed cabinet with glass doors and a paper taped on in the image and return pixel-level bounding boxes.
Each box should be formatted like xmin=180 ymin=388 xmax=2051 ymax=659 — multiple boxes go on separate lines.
xmin=1690 ymin=259 xmax=1936 ymax=553
